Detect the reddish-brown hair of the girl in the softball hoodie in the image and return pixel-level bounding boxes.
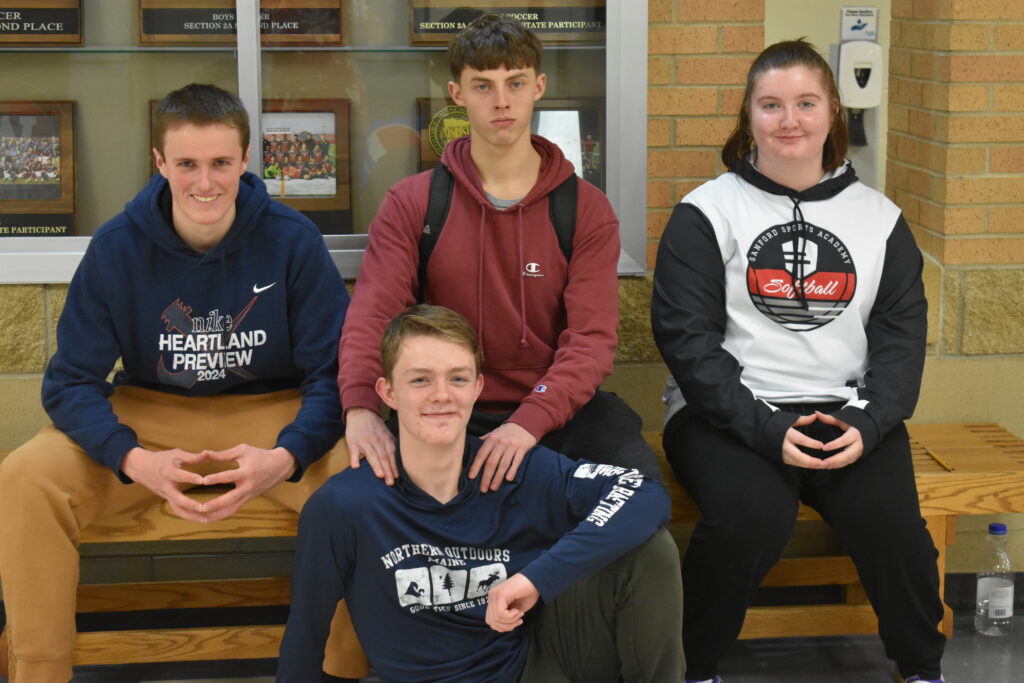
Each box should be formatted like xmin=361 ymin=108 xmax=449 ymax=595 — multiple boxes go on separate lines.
xmin=722 ymin=38 xmax=850 ymax=172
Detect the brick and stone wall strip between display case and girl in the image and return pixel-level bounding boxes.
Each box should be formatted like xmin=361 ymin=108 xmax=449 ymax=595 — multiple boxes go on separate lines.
xmin=605 ymin=0 xmax=764 ymax=429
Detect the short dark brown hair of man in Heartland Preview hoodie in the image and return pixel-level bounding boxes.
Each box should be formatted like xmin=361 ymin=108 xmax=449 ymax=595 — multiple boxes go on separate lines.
xmin=153 ymin=83 xmax=249 ymax=155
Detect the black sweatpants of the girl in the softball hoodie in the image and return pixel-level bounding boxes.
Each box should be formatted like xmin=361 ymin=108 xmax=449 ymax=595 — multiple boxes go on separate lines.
xmin=665 ymin=403 xmax=945 ymax=679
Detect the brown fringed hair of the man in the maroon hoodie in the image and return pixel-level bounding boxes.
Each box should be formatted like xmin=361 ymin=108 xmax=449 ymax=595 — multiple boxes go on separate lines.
xmin=449 ymin=13 xmax=544 ymax=81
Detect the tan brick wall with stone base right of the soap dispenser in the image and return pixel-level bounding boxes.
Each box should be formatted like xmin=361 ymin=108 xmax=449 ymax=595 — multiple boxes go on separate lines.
xmin=886 ymin=0 xmax=1024 ymax=355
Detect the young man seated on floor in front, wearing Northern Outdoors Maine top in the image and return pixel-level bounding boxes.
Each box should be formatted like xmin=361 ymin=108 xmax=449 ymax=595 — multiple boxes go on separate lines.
xmin=278 ymin=305 xmax=683 ymax=683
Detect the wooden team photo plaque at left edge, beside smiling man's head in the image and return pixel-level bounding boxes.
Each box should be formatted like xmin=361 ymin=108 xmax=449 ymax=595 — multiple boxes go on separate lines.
xmin=0 ymin=100 xmax=75 ymax=237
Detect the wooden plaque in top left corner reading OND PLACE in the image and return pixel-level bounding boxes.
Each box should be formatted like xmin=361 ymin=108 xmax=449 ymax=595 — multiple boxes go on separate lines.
xmin=0 ymin=0 xmax=82 ymax=47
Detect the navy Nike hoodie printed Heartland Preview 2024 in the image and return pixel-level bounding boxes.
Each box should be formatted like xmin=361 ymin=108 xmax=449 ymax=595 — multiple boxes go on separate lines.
xmin=43 ymin=173 xmax=348 ymax=482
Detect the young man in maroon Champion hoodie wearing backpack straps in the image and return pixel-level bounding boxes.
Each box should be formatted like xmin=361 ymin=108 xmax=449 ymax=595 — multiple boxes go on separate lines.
xmin=338 ymin=14 xmax=660 ymax=490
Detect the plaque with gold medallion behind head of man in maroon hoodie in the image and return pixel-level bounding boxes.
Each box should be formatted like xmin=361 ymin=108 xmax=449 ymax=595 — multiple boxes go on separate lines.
xmin=417 ymin=97 xmax=605 ymax=191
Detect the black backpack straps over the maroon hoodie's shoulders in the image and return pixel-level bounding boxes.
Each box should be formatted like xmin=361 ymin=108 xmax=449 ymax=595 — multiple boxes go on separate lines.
xmin=419 ymin=164 xmax=579 ymax=302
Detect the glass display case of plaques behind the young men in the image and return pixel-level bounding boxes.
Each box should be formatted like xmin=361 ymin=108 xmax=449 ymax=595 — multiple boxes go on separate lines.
xmin=0 ymin=0 xmax=647 ymax=284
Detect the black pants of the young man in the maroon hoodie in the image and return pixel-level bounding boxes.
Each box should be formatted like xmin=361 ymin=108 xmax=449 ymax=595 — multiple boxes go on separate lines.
xmin=467 ymin=389 xmax=663 ymax=481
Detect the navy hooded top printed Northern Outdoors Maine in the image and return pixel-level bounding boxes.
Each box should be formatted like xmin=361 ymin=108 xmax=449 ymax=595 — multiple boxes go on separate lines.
xmin=278 ymin=436 xmax=669 ymax=683
